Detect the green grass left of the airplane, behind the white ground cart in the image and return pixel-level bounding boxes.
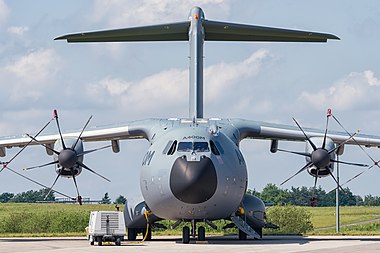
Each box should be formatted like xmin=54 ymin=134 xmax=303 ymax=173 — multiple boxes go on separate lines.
xmin=0 ymin=203 xmax=119 ymax=237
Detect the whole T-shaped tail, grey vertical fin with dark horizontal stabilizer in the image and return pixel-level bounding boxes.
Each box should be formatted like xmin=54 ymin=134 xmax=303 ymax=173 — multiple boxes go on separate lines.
xmin=56 ymin=7 xmax=339 ymax=119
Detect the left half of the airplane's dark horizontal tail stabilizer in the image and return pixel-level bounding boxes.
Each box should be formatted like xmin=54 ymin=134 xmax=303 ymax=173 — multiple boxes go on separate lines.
xmin=55 ymin=21 xmax=190 ymax=42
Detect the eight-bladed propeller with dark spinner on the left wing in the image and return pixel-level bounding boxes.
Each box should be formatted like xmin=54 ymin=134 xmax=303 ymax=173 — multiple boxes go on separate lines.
xmin=24 ymin=110 xmax=111 ymax=205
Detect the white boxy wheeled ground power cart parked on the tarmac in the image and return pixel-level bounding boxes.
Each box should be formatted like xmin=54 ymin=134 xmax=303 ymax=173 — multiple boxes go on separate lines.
xmin=88 ymin=211 xmax=126 ymax=246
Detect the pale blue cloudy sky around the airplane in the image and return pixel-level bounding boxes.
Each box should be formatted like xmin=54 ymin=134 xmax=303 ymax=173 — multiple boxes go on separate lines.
xmin=0 ymin=0 xmax=380 ymax=202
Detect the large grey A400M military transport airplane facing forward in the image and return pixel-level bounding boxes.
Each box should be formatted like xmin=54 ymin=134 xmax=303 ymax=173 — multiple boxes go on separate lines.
xmin=0 ymin=7 xmax=380 ymax=244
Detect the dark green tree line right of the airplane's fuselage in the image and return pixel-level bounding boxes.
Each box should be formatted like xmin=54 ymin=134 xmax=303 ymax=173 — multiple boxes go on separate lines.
xmin=248 ymin=184 xmax=380 ymax=206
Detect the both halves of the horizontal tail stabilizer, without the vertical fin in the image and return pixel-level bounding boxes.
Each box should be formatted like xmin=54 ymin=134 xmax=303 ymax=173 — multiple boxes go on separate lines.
xmin=56 ymin=20 xmax=339 ymax=42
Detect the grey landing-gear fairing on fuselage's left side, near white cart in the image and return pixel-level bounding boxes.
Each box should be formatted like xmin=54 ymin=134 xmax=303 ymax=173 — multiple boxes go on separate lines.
xmin=123 ymin=199 xmax=161 ymax=229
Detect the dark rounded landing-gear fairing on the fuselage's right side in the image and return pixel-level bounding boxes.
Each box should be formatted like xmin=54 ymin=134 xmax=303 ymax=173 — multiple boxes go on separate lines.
xmin=242 ymin=194 xmax=266 ymax=229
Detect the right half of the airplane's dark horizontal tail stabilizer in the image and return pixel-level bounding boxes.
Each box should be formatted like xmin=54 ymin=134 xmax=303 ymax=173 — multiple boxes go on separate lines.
xmin=203 ymin=20 xmax=339 ymax=42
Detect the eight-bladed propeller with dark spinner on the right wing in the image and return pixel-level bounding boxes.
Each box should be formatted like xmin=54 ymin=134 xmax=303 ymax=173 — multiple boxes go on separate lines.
xmin=278 ymin=109 xmax=368 ymax=206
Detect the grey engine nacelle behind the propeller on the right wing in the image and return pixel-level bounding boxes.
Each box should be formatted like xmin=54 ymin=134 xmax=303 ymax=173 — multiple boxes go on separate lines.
xmin=305 ymin=137 xmax=335 ymax=178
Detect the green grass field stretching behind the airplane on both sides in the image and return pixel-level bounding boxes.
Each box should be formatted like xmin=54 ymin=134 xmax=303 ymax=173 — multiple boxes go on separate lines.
xmin=0 ymin=203 xmax=380 ymax=237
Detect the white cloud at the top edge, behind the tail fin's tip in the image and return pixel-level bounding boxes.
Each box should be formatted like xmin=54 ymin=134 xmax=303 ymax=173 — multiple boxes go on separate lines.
xmin=90 ymin=0 xmax=230 ymax=27
